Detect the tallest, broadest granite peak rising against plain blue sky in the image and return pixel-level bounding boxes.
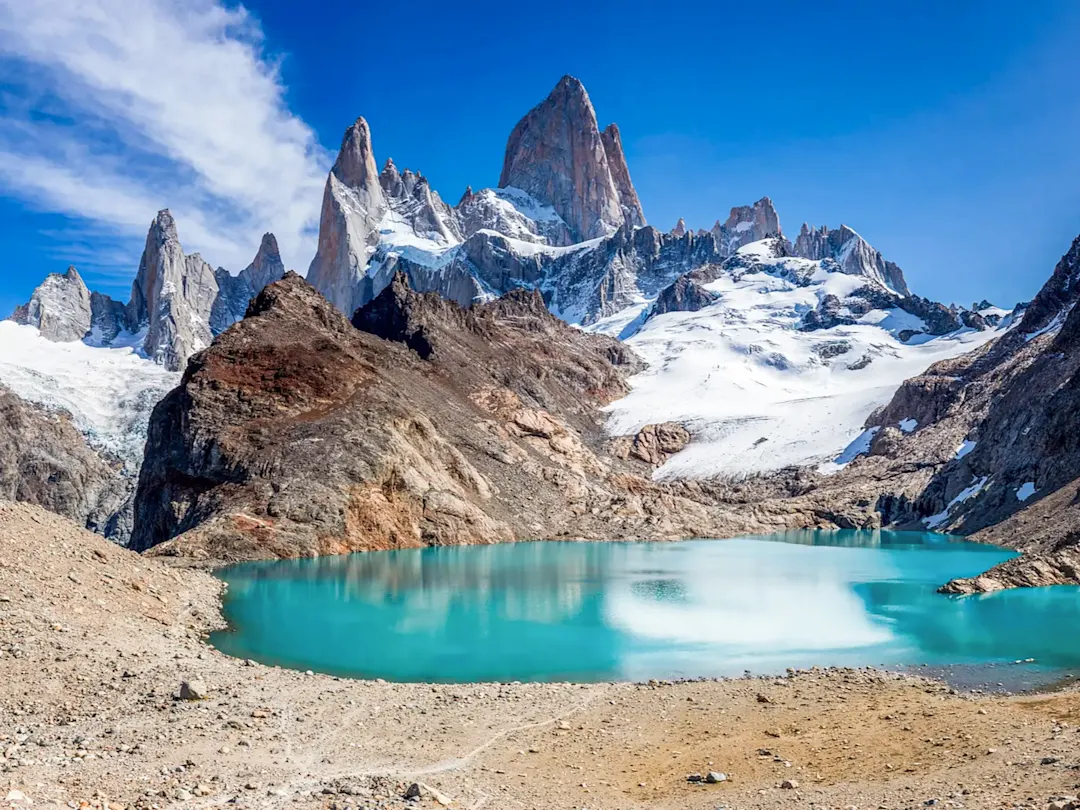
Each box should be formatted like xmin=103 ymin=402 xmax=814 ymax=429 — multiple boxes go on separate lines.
xmin=499 ymin=76 xmax=637 ymax=242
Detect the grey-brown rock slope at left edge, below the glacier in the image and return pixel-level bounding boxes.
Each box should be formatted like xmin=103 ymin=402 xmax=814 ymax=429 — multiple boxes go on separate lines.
xmin=0 ymin=387 xmax=134 ymax=541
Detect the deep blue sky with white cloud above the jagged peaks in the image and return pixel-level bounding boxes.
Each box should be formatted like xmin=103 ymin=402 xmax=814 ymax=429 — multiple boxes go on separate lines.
xmin=0 ymin=0 xmax=1080 ymax=312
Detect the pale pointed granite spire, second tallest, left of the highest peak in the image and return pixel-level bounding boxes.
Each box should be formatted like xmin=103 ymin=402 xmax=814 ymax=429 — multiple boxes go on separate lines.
xmin=308 ymin=118 xmax=396 ymax=315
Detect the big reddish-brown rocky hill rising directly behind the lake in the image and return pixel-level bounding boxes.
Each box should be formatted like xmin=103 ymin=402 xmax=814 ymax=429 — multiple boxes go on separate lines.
xmin=133 ymin=274 xmax=821 ymax=559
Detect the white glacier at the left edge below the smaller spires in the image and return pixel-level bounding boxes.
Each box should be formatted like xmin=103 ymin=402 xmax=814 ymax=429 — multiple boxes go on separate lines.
xmin=0 ymin=321 xmax=180 ymax=473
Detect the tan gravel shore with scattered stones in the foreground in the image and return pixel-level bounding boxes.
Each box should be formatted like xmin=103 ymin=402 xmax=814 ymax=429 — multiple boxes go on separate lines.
xmin=0 ymin=503 xmax=1080 ymax=810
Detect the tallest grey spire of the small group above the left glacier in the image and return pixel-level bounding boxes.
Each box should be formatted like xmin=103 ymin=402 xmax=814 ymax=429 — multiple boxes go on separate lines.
xmin=126 ymin=208 xmax=219 ymax=372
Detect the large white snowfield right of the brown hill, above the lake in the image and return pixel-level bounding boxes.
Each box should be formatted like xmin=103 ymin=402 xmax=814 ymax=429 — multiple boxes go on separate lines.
xmin=592 ymin=243 xmax=1001 ymax=480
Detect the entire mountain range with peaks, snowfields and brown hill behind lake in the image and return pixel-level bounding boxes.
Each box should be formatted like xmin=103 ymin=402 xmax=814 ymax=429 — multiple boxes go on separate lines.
xmin=0 ymin=77 xmax=1080 ymax=590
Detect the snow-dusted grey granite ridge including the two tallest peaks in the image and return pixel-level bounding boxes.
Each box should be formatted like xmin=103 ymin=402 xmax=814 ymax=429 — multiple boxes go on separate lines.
xmin=308 ymin=76 xmax=937 ymax=325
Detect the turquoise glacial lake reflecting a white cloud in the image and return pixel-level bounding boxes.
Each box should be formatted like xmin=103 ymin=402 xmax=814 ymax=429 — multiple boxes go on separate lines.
xmin=211 ymin=531 xmax=1080 ymax=683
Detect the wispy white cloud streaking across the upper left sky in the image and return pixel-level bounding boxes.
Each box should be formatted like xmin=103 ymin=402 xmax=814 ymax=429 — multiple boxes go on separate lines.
xmin=0 ymin=0 xmax=329 ymax=282
